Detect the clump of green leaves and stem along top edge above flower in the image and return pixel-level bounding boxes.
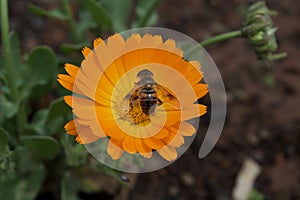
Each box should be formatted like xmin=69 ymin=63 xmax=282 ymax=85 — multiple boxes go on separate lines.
xmin=28 ymin=0 xmax=161 ymax=54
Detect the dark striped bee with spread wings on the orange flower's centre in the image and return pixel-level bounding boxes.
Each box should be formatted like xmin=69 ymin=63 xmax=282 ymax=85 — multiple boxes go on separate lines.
xmin=122 ymin=69 xmax=180 ymax=125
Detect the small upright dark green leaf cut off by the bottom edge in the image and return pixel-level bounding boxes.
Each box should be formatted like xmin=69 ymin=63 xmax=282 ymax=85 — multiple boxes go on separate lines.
xmin=61 ymin=173 xmax=79 ymax=200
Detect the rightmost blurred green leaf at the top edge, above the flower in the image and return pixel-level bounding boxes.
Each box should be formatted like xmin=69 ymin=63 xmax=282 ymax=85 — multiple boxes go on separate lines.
xmin=132 ymin=0 xmax=161 ymax=28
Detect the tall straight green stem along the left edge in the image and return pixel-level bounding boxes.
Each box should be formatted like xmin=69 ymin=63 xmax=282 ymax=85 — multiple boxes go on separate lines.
xmin=1 ymin=0 xmax=18 ymax=101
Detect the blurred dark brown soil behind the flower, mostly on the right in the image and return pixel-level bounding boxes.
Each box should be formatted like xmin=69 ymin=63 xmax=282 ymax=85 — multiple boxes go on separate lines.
xmin=11 ymin=0 xmax=300 ymax=200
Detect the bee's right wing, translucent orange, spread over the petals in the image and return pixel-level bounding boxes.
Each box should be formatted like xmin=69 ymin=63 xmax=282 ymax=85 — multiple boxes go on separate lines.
xmin=155 ymin=84 xmax=180 ymax=109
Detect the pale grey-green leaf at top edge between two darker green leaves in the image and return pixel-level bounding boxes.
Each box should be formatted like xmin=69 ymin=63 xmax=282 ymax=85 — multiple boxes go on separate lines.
xmin=99 ymin=0 xmax=132 ymax=32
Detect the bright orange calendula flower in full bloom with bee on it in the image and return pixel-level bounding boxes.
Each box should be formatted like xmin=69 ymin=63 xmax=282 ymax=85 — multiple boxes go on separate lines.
xmin=58 ymin=34 xmax=208 ymax=161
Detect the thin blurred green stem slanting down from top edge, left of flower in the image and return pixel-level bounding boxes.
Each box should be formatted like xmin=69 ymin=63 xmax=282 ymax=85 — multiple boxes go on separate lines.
xmin=62 ymin=0 xmax=80 ymax=43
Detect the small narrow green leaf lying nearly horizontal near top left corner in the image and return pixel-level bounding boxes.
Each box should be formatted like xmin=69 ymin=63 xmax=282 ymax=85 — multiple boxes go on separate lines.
xmin=28 ymin=3 xmax=67 ymax=20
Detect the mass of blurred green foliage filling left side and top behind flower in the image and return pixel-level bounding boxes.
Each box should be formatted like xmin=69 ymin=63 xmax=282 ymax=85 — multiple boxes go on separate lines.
xmin=0 ymin=0 xmax=160 ymax=200
